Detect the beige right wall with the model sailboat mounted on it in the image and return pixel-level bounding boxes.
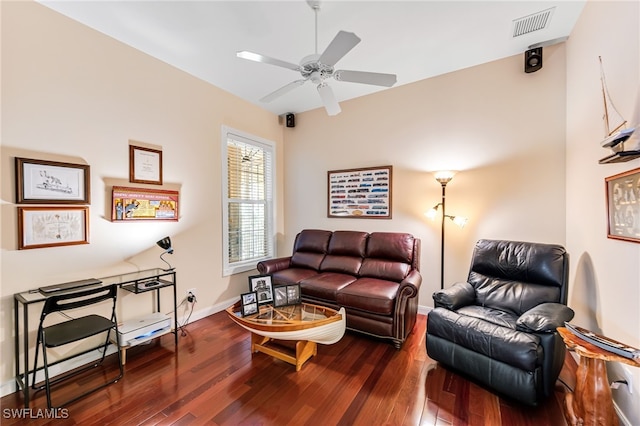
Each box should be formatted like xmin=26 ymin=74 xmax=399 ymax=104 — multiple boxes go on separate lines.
xmin=566 ymin=1 xmax=640 ymax=425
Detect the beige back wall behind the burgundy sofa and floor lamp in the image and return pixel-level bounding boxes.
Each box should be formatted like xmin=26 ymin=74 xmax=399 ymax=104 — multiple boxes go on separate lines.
xmin=281 ymin=45 xmax=566 ymax=307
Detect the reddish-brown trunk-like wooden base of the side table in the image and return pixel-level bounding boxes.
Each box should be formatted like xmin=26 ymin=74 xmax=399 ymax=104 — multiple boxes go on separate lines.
xmin=565 ymin=356 xmax=618 ymax=426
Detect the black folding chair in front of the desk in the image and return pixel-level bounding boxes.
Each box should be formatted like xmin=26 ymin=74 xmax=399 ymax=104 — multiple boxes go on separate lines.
xmin=31 ymin=284 xmax=124 ymax=408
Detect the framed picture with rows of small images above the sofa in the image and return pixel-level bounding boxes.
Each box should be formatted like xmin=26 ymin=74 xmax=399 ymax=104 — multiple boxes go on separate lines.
xmin=327 ymin=166 xmax=393 ymax=219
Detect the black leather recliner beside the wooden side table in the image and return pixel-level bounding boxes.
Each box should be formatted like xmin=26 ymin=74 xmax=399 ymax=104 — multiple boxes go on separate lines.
xmin=426 ymin=240 xmax=574 ymax=405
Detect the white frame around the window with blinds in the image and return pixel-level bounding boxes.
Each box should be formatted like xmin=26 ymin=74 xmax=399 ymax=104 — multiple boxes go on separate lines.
xmin=220 ymin=126 xmax=276 ymax=276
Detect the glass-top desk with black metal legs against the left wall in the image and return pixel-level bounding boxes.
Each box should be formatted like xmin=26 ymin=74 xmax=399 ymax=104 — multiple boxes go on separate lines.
xmin=13 ymin=268 xmax=178 ymax=408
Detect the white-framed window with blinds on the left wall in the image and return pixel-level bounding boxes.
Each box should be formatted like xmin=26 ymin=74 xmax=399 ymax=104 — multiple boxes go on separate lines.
xmin=222 ymin=127 xmax=274 ymax=275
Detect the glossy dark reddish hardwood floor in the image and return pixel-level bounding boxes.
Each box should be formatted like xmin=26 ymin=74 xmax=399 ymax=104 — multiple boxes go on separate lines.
xmin=0 ymin=312 xmax=575 ymax=426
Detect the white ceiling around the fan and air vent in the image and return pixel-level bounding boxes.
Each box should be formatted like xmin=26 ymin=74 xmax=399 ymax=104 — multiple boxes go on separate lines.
xmin=35 ymin=0 xmax=586 ymax=115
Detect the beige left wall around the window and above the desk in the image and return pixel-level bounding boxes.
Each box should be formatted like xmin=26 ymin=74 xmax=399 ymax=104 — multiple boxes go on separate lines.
xmin=0 ymin=2 xmax=283 ymax=390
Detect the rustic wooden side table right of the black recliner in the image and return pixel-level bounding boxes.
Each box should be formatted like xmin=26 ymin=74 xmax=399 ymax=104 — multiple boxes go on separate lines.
xmin=558 ymin=327 xmax=640 ymax=426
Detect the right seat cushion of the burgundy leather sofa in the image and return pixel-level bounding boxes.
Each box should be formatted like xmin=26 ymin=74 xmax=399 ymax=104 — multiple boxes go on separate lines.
xmin=337 ymin=278 xmax=400 ymax=315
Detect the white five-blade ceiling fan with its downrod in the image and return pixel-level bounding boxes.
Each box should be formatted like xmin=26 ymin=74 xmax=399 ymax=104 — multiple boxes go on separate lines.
xmin=236 ymin=0 xmax=397 ymax=115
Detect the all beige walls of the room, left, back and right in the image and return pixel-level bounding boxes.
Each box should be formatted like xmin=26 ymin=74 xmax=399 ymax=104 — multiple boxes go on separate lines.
xmin=0 ymin=2 xmax=640 ymax=423
